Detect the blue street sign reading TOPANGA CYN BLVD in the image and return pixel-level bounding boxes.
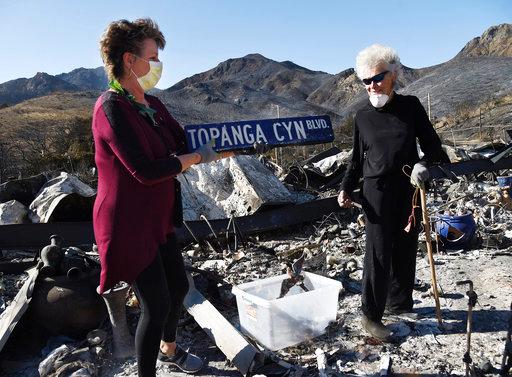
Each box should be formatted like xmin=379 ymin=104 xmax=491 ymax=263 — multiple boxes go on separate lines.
xmin=185 ymin=115 xmax=334 ymax=152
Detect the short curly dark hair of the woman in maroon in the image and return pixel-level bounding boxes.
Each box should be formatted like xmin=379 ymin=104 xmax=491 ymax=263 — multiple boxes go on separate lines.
xmin=100 ymin=18 xmax=165 ymax=80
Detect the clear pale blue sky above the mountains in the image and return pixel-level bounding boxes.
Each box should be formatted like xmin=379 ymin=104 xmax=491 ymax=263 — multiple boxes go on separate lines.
xmin=0 ymin=0 xmax=512 ymax=88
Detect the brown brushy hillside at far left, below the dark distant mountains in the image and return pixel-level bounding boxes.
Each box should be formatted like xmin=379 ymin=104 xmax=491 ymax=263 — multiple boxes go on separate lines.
xmin=0 ymin=92 xmax=97 ymax=178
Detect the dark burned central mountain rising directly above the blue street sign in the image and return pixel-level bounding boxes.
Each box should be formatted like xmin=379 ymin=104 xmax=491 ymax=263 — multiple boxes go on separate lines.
xmin=157 ymin=54 xmax=336 ymax=123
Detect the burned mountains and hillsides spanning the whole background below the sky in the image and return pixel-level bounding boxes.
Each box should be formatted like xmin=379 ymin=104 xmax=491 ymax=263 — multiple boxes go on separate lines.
xmin=0 ymin=24 xmax=512 ymax=180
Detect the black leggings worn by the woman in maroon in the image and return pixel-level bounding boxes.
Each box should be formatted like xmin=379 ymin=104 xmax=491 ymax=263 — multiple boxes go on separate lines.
xmin=133 ymin=233 xmax=188 ymax=377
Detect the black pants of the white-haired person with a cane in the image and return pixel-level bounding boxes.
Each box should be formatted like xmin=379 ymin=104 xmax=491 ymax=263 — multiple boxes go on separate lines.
xmin=361 ymin=174 xmax=421 ymax=320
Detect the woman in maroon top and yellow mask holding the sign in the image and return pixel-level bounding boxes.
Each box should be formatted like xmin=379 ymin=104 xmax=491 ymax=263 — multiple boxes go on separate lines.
xmin=92 ymin=19 xmax=227 ymax=377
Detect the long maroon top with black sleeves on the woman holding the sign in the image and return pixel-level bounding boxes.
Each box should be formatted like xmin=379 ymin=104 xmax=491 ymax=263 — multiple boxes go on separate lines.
xmin=92 ymin=91 xmax=186 ymax=293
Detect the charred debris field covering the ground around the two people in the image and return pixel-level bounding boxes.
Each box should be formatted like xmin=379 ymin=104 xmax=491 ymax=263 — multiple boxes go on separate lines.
xmin=0 ymin=140 xmax=512 ymax=376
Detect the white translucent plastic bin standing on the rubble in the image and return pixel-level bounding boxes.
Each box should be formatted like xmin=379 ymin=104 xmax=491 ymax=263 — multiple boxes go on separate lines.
xmin=232 ymin=272 xmax=341 ymax=351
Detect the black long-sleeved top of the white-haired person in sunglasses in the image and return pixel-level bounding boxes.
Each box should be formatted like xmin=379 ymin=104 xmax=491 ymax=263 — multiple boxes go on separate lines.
xmin=341 ymin=93 xmax=450 ymax=193
